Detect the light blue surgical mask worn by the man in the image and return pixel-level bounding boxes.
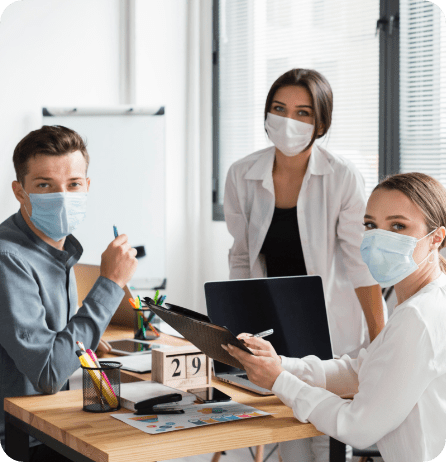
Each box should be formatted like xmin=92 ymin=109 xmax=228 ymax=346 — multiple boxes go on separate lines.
xmin=23 ymin=189 xmax=87 ymax=242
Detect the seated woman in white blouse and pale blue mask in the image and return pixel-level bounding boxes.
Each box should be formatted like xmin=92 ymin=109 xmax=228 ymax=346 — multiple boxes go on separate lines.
xmin=224 ymin=173 xmax=446 ymax=462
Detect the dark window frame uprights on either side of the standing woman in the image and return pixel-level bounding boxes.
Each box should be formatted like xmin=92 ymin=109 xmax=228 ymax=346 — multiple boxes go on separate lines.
xmin=212 ymin=0 xmax=400 ymax=221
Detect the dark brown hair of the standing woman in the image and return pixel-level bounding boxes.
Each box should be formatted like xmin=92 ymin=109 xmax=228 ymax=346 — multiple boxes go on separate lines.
xmin=265 ymin=69 xmax=333 ymax=149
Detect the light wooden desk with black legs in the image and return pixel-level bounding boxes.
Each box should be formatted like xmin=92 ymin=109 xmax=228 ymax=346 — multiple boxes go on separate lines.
xmin=5 ymin=328 xmax=345 ymax=462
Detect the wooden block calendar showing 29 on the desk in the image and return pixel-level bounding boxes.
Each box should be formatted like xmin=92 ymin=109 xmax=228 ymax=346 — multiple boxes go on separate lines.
xmin=152 ymin=346 xmax=211 ymax=390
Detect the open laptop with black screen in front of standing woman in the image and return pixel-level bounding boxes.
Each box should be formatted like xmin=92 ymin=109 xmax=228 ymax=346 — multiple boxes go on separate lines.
xmin=204 ymin=276 xmax=333 ymax=394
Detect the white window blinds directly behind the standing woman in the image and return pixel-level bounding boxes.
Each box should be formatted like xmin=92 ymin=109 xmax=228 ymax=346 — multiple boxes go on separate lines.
xmin=214 ymin=0 xmax=379 ymax=204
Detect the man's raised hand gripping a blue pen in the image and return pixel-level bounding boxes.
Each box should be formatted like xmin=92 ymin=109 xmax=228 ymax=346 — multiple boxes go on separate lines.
xmin=101 ymin=234 xmax=138 ymax=287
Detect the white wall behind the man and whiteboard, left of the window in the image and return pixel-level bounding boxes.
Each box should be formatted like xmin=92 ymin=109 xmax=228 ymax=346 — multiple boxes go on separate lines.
xmin=0 ymin=0 xmax=232 ymax=312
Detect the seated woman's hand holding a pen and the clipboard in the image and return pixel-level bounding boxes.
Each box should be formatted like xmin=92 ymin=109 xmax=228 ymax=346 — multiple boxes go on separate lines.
xmin=222 ymin=334 xmax=284 ymax=390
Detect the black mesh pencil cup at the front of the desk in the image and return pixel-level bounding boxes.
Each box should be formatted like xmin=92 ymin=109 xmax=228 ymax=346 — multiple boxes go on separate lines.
xmin=81 ymin=361 xmax=122 ymax=412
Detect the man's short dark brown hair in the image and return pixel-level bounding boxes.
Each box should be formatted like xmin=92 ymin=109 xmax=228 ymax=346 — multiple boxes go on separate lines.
xmin=12 ymin=125 xmax=90 ymax=184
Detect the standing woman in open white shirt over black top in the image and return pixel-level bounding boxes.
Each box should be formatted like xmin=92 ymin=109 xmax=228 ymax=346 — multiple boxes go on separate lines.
xmin=224 ymin=69 xmax=385 ymax=462
